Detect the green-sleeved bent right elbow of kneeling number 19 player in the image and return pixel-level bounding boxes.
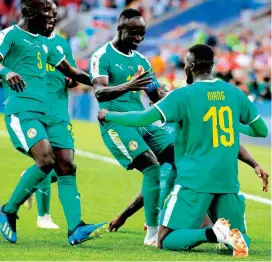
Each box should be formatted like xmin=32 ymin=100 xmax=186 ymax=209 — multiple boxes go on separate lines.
xmin=239 ymin=117 xmax=268 ymax=137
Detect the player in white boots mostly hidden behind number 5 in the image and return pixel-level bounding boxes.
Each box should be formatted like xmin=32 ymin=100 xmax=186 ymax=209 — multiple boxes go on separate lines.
xmin=21 ymin=1 xmax=77 ymax=229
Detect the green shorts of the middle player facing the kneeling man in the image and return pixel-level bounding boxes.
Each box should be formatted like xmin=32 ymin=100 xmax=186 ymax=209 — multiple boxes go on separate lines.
xmin=102 ymin=124 xmax=174 ymax=169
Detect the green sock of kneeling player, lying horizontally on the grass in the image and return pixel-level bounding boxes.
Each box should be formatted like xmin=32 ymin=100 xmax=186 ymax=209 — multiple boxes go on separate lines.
xmin=162 ymin=229 xmax=207 ymax=251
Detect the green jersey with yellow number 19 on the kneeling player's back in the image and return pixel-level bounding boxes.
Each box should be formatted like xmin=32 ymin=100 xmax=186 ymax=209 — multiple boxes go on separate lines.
xmin=155 ymin=80 xmax=259 ymax=193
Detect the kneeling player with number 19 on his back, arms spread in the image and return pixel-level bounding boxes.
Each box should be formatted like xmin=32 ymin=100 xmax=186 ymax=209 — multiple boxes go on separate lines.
xmin=99 ymin=45 xmax=268 ymax=257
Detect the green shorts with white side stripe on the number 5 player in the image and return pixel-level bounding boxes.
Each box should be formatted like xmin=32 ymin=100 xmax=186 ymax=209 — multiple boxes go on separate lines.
xmin=5 ymin=112 xmax=74 ymax=154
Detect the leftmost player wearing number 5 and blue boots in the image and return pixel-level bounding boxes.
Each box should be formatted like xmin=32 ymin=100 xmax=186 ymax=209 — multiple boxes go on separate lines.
xmin=0 ymin=0 xmax=105 ymax=245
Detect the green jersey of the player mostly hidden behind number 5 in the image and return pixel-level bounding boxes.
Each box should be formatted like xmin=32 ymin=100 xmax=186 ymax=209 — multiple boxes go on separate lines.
xmin=46 ymin=33 xmax=76 ymax=123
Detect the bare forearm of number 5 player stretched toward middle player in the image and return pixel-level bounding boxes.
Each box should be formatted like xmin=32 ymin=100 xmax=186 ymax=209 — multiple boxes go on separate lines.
xmin=56 ymin=59 xmax=92 ymax=86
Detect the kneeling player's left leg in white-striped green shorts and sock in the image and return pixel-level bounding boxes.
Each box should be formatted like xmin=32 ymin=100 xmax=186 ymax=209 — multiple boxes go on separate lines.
xmin=159 ymin=185 xmax=217 ymax=251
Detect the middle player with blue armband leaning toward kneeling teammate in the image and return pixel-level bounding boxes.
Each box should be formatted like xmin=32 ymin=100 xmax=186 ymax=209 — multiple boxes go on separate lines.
xmin=90 ymin=9 xmax=175 ymax=245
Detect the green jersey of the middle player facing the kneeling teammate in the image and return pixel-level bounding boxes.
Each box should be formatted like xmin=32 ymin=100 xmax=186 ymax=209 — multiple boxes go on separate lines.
xmin=89 ymin=42 xmax=151 ymax=112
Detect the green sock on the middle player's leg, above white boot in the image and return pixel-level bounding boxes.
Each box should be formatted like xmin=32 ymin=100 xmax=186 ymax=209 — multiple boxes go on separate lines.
xmin=142 ymin=165 xmax=160 ymax=226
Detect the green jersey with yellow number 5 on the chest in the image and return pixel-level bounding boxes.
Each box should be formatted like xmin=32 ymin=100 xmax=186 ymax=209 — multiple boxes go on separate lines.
xmin=0 ymin=25 xmax=65 ymax=115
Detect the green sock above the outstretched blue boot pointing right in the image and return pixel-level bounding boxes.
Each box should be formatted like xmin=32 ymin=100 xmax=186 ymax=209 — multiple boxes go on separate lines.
xmin=58 ymin=176 xmax=81 ymax=230
